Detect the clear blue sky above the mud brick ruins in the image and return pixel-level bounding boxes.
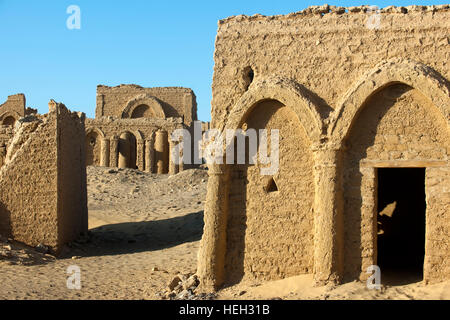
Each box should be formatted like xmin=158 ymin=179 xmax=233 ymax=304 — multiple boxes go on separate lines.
xmin=0 ymin=0 xmax=445 ymax=121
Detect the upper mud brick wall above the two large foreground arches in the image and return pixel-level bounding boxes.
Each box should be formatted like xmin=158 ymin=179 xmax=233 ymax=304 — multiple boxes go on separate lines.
xmin=212 ymin=6 xmax=450 ymax=127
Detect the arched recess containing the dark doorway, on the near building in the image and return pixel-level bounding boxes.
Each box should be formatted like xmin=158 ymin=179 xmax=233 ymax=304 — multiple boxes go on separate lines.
xmin=343 ymin=82 xmax=449 ymax=281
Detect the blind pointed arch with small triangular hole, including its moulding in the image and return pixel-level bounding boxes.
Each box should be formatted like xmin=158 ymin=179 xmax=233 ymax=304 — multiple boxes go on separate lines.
xmin=219 ymin=78 xmax=324 ymax=283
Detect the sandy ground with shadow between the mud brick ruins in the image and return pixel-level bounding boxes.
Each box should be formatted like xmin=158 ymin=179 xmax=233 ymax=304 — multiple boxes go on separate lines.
xmin=0 ymin=167 xmax=450 ymax=300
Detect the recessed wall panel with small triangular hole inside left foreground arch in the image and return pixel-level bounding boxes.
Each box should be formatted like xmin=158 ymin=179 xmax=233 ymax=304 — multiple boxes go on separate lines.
xmin=225 ymin=100 xmax=314 ymax=283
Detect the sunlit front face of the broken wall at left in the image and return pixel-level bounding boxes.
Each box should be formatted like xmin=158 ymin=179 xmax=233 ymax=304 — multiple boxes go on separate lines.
xmin=0 ymin=113 xmax=58 ymax=247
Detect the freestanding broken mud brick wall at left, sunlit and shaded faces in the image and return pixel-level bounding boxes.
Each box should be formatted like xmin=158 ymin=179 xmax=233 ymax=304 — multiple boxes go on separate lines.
xmin=0 ymin=102 xmax=87 ymax=253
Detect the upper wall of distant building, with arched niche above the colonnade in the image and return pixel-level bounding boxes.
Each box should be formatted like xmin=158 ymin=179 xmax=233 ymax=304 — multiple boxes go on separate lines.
xmin=95 ymin=85 xmax=197 ymax=126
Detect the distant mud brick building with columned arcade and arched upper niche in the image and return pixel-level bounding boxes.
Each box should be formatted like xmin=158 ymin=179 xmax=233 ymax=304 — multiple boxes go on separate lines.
xmin=86 ymin=85 xmax=197 ymax=174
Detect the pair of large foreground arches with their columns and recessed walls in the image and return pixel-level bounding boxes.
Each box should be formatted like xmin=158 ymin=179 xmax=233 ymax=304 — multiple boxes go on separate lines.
xmin=199 ymin=60 xmax=450 ymax=287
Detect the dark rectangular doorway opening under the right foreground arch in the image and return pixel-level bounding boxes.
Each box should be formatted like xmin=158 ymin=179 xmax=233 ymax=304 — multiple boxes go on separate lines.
xmin=377 ymin=168 xmax=426 ymax=284
